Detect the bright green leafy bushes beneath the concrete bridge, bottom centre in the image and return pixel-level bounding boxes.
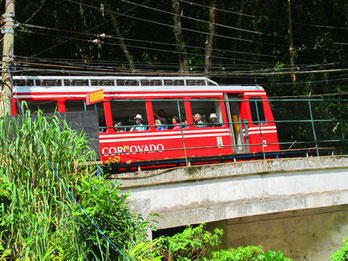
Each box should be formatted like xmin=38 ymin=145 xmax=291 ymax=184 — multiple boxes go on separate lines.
xmin=147 ymin=224 xmax=292 ymax=261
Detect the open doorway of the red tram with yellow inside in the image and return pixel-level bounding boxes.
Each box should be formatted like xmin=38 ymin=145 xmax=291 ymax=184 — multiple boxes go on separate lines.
xmin=225 ymin=94 xmax=247 ymax=153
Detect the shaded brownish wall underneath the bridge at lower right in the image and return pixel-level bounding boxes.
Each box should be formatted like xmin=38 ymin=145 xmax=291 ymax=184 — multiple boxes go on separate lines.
xmin=208 ymin=205 xmax=348 ymax=261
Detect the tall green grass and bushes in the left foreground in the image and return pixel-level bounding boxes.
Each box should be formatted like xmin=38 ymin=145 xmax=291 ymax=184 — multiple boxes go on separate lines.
xmin=0 ymin=109 xmax=147 ymax=260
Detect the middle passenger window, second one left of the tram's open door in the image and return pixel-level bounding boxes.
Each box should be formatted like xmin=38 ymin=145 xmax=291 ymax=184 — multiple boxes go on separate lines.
xmin=152 ymin=100 xmax=187 ymax=130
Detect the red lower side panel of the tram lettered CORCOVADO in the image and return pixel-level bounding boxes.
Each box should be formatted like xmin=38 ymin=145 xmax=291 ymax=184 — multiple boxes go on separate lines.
xmin=99 ymin=127 xmax=232 ymax=162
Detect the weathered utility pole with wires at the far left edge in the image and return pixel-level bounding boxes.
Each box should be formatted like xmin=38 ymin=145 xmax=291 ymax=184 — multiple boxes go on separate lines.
xmin=0 ymin=0 xmax=15 ymax=117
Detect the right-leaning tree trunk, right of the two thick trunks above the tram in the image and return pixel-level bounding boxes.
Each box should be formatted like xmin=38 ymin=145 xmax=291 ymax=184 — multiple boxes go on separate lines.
xmin=205 ymin=0 xmax=216 ymax=72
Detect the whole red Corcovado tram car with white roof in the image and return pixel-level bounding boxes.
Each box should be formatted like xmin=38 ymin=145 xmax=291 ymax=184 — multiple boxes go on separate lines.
xmin=13 ymin=76 xmax=279 ymax=167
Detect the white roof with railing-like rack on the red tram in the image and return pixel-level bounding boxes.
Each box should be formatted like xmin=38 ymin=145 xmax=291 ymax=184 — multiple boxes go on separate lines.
xmin=13 ymin=76 xmax=264 ymax=92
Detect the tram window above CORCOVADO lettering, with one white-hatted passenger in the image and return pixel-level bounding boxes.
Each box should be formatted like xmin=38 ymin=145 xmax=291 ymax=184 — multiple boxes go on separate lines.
xmin=111 ymin=100 xmax=148 ymax=131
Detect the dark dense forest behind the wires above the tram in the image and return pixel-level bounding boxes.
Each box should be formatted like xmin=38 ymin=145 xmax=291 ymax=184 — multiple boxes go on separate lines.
xmin=12 ymin=0 xmax=348 ymax=96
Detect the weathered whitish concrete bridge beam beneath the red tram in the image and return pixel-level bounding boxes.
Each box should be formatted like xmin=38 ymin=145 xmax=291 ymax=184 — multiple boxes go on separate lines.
xmin=113 ymin=156 xmax=348 ymax=260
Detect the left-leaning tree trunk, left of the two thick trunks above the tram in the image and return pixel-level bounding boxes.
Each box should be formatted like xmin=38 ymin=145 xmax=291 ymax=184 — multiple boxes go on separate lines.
xmin=172 ymin=0 xmax=188 ymax=72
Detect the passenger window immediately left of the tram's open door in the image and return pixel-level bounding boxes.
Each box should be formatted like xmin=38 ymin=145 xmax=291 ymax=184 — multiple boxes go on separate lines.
xmin=191 ymin=99 xmax=223 ymax=128
